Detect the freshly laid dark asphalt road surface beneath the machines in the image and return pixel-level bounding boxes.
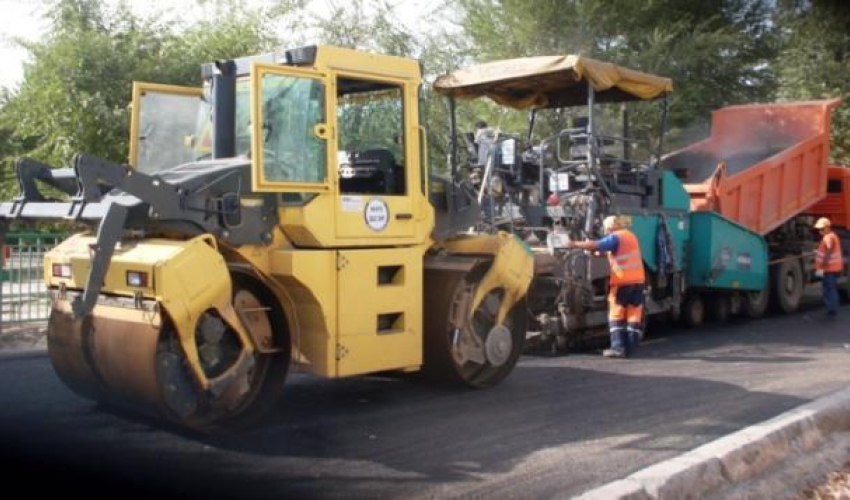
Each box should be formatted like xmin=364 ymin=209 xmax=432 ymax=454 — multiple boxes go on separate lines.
xmin=0 ymin=300 xmax=850 ymax=497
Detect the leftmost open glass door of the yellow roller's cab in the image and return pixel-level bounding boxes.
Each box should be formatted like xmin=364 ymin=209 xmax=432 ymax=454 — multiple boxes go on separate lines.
xmin=129 ymin=82 xmax=204 ymax=173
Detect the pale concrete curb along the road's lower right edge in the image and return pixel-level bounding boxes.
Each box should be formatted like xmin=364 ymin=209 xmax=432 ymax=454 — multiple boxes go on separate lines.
xmin=578 ymin=388 xmax=850 ymax=500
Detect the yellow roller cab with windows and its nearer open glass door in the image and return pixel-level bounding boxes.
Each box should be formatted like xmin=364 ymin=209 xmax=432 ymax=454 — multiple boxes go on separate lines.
xmin=251 ymin=62 xmax=433 ymax=248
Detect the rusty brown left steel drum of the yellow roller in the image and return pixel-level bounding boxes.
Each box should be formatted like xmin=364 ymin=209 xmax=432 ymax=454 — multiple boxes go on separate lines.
xmin=47 ymin=278 xmax=290 ymax=431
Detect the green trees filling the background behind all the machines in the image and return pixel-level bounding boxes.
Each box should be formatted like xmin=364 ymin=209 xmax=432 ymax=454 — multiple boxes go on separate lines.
xmin=0 ymin=0 xmax=850 ymax=192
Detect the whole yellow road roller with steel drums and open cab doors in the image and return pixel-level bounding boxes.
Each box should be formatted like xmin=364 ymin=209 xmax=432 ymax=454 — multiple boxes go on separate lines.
xmin=9 ymin=46 xmax=533 ymax=428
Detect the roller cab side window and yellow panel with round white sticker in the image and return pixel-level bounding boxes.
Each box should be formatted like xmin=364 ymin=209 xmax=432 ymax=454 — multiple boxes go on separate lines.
xmin=331 ymin=73 xmax=419 ymax=241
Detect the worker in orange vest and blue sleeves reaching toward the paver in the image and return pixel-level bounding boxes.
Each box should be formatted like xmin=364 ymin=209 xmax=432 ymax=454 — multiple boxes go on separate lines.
xmin=567 ymin=215 xmax=646 ymax=358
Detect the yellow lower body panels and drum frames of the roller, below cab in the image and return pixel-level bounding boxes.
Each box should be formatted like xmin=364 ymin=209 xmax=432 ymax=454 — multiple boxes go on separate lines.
xmin=45 ymin=233 xmax=532 ymax=385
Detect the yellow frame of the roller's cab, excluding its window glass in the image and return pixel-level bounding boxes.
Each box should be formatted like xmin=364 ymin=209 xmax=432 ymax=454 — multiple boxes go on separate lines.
xmin=243 ymin=47 xmax=434 ymax=248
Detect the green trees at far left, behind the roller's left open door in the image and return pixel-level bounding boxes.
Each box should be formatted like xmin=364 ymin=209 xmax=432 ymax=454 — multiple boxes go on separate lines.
xmin=0 ymin=0 xmax=292 ymax=194
